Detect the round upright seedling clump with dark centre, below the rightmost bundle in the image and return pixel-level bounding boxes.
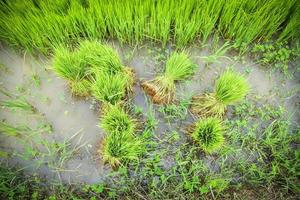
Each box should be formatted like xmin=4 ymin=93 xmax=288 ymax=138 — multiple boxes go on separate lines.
xmin=191 ymin=117 xmax=224 ymax=153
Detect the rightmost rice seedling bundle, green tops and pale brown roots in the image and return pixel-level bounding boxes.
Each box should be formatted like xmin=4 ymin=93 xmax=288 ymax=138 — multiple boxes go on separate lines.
xmin=191 ymin=70 xmax=250 ymax=117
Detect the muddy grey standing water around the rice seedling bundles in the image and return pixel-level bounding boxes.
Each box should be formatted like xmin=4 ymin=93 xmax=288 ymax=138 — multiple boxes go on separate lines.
xmin=0 ymin=43 xmax=300 ymax=183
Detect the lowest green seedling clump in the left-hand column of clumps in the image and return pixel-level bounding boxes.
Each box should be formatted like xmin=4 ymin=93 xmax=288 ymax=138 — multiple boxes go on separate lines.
xmin=99 ymin=131 xmax=146 ymax=168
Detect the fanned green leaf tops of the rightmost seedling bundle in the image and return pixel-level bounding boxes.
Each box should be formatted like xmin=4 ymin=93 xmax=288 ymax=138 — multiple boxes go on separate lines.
xmin=215 ymin=70 xmax=250 ymax=105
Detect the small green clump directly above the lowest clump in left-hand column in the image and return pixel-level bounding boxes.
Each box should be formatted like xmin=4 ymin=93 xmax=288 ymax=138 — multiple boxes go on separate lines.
xmin=100 ymin=105 xmax=136 ymax=134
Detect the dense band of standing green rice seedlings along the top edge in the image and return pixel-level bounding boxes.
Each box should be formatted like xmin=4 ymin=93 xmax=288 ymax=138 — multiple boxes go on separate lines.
xmin=0 ymin=0 xmax=300 ymax=53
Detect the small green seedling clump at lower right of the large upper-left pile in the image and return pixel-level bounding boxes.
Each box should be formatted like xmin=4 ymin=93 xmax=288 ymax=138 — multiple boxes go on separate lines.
xmin=91 ymin=71 xmax=129 ymax=105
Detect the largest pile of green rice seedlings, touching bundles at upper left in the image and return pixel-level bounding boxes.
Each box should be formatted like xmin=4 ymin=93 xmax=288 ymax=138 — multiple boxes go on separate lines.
xmin=53 ymin=41 xmax=133 ymax=104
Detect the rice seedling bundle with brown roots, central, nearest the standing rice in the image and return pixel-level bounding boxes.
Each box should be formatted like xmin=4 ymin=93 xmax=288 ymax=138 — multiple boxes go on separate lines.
xmin=142 ymin=52 xmax=196 ymax=104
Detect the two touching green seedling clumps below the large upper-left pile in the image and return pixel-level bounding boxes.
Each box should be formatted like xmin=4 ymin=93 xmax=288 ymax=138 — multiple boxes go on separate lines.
xmin=99 ymin=105 xmax=145 ymax=168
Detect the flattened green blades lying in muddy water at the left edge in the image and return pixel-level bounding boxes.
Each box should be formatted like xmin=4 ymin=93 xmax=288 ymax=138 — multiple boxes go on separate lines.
xmin=0 ymin=98 xmax=36 ymax=113
